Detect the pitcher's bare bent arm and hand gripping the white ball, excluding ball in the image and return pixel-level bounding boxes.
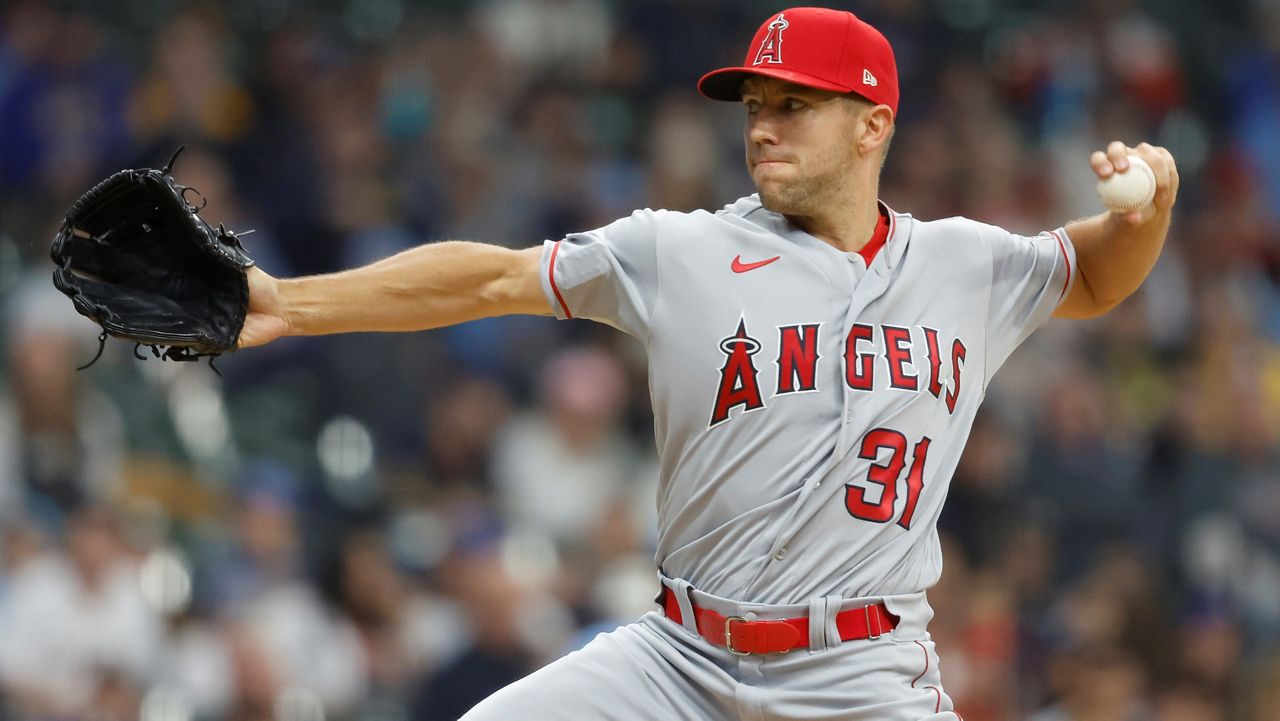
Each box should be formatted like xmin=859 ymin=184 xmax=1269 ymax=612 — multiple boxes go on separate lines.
xmin=1053 ymin=141 xmax=1178 ymax=318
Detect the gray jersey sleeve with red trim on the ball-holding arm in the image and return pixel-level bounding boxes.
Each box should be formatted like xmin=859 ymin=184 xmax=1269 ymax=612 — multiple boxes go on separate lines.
xmin=982 ymin=225 xmax=1076 ymax=382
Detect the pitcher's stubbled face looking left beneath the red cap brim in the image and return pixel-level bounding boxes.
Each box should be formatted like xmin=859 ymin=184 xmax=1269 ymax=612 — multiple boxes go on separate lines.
xmin=742 ymin=77 xmax=864 ymax=215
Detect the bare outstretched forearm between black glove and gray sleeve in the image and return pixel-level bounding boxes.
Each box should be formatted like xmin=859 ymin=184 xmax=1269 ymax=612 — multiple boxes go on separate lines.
xmin=239 ymin=241 xmax=552 ymax=348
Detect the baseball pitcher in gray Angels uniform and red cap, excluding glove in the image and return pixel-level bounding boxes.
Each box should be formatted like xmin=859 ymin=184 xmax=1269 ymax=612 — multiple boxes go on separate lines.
xmin=241 ymin=8 xmax=1178 ymax=721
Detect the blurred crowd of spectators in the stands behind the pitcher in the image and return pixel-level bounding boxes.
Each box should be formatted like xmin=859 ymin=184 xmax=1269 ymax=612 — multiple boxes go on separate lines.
xmin=0 ymin=0 xmax=1280 ymax=721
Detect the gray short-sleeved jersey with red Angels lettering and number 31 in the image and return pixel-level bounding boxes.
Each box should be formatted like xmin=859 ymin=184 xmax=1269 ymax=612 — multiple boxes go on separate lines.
xmin=541 ymin=196 xmax=1075 ymax=604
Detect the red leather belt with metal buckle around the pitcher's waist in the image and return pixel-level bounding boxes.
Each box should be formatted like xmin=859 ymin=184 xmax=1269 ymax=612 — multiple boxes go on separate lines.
xmin=662 ymin=585 xmax=899 ymax=656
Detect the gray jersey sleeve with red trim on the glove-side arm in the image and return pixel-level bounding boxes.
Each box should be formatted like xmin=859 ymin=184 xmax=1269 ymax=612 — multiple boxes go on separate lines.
xmin=541 ymin=210 xmax=662 ymax=339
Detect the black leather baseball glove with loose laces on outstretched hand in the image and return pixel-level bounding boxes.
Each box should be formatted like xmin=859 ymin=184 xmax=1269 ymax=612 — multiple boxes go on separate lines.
xmin=50 ymin=147 xmax=253 ymax=368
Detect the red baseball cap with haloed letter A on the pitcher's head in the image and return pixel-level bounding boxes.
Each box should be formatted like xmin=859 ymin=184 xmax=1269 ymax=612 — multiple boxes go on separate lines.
xmin=698 ymin=8 xmax=897 ymax=115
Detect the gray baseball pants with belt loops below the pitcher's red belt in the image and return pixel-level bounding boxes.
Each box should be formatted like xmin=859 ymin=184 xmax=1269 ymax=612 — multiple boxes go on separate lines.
xmin=462 ymin=583 xmax=960 ymax=721
